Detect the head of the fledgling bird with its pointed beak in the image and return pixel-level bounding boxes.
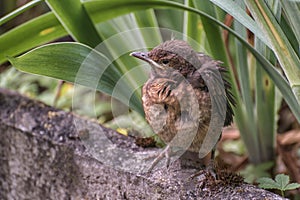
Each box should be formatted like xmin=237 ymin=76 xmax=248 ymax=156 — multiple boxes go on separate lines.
xmin=130 ymin=40 xmax=198 ymax=76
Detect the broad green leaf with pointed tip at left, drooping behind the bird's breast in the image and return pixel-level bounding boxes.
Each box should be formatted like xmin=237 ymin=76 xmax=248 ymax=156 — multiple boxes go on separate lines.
xmin=9 ymin=43 xmax=143 ymax=114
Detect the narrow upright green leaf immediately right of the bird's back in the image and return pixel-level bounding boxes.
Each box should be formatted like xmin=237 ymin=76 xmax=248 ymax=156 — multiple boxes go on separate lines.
xmin=232 ymin=1 xmax=261 ymax=163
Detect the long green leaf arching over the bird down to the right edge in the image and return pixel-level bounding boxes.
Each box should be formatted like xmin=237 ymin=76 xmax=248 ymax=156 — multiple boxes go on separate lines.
xmin=84 ymin=0 xmax=300 ymax=121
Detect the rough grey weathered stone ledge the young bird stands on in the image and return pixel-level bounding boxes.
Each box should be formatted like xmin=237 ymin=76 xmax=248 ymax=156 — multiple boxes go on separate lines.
xmin=0 ymin=89 xmax=282 ymax=199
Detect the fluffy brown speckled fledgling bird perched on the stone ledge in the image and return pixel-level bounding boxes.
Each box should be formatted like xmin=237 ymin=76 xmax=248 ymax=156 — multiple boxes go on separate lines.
xmin=131 ymin=40 xmax=235 ymax=169
